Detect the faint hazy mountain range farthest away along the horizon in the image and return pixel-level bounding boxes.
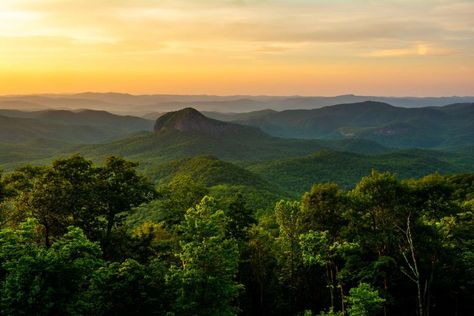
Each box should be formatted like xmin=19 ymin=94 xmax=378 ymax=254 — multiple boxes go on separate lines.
xmin=0 ymin=92 xmax=474 ymax=115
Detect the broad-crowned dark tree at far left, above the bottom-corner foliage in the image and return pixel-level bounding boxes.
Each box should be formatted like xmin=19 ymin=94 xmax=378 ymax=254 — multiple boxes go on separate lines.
xmin=6 ymin=155 xmax=100 ymax=245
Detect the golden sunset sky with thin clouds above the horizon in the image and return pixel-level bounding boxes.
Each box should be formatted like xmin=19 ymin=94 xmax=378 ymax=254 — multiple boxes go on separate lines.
xmin=0 ymin=0 xmax=474 ymax=96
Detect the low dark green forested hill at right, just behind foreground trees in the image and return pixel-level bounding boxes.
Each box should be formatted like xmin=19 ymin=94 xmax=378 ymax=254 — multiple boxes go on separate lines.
xmin=247 ymin=150 xmax=474 ymax=196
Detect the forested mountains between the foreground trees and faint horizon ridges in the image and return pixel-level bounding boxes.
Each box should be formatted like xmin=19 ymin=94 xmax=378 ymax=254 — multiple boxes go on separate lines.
xmin=0 ymin=102 xmax=474 ymax=196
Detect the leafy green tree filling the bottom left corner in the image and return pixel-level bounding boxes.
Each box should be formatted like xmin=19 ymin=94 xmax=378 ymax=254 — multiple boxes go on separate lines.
xmin=0 ymin=221 xmax=102 ymax=315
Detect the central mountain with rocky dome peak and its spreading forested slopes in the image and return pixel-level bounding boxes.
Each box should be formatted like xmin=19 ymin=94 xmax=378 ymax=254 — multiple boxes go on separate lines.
xmin=78 ymin=108 xmax=374 ymax=163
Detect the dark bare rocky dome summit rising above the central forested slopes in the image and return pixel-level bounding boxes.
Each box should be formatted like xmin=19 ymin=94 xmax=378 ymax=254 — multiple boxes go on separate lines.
xmin=155 ymin=108 xmax=261 ymax=136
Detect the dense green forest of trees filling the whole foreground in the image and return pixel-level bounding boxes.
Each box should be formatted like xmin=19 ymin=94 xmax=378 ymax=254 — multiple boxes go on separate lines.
xmin=0 ymin=155 xmax=474 ymax=316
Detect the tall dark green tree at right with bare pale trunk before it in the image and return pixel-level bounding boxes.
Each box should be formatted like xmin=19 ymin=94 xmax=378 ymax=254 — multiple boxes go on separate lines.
xmin=404 ymin=174 xmax=462 ymax=315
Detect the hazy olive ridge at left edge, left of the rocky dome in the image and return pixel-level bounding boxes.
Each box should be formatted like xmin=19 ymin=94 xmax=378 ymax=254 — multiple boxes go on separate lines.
xmin=0 ymin=110 xmax=153 ymax=168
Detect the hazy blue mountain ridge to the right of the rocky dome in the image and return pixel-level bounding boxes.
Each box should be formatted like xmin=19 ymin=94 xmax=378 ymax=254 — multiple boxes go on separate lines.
xmin=208 ymin=101 xmax=474 ymax=149
